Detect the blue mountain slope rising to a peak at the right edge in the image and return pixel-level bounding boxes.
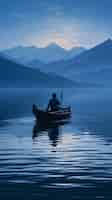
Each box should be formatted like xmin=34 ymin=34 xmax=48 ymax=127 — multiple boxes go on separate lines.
xmin=45 ymin=39 xmax=112 ymax=82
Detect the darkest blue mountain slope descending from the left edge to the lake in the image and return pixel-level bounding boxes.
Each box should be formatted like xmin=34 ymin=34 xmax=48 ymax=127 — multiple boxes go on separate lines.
xmin=0 ymin=57 xmax=73 ymax=87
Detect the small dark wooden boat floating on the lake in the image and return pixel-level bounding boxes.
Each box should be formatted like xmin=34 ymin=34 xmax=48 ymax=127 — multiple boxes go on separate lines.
xmin=32 ymin=104 xmax=71 ymax=124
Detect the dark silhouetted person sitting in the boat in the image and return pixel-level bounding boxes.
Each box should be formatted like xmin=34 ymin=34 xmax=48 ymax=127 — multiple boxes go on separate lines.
xmin=47 ymin=93 xmax=61 ymax=111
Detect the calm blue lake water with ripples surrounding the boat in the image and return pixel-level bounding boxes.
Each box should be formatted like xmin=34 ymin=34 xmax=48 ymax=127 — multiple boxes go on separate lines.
xmin=0 ymin=88 xmax=112 ymax=200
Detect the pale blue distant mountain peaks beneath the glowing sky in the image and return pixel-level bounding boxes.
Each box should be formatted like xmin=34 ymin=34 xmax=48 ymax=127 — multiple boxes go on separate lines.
xmin=3 ymin=44 xmax=85 ymax=63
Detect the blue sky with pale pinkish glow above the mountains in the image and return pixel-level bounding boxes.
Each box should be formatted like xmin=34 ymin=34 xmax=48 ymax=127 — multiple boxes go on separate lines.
xmin=0 ymin=0 xmax=112 ymax=49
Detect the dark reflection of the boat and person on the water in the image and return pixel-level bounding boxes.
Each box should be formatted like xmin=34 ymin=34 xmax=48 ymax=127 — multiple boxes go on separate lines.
xmin=32 ymin=120 xmax=70 ymax=147
